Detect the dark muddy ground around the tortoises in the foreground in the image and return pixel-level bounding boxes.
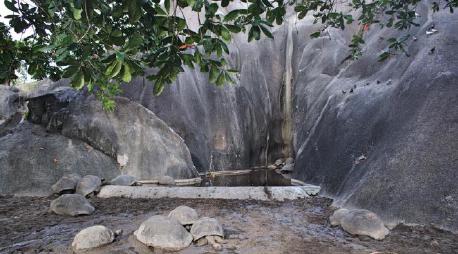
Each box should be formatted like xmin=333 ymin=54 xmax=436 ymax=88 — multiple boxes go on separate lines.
xmin=0 ymin=197 xmax=458 ymax=254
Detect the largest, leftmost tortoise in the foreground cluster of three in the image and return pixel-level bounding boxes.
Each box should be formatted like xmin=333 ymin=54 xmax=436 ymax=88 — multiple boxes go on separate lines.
xmin=134 ymin=215 xmax=193 ymax=251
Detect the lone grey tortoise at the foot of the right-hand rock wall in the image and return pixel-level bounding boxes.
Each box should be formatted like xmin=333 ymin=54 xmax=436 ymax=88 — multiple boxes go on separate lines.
xmin=329 ymin=209 xmax=390 ymax=240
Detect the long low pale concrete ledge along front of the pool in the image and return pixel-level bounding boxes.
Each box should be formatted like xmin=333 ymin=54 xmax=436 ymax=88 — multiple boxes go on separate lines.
xmin=98 ymin=185 xmax=320 ymax=201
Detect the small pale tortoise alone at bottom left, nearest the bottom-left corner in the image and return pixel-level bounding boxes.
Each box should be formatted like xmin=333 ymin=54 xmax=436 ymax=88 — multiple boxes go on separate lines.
xmin=72 ymin=225 xmax=115 ymax=250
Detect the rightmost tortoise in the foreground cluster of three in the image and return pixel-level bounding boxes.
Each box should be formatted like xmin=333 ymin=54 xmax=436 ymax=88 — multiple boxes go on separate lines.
xmin=191 ymin=217 xmax=224 ymax=250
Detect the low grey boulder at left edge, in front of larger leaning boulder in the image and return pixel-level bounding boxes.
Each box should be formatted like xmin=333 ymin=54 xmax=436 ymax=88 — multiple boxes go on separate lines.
xmin=0 ymin=122 xmax=120 ymax=196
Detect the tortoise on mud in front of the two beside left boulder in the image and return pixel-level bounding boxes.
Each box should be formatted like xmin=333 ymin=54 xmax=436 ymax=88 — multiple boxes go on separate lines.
xmin=50 ymin=194 xmax=95 ymax=216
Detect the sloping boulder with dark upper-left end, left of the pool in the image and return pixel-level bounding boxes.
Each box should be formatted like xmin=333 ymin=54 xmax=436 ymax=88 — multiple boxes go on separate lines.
xmin=25 ymin=87 xmax=197 ymax=179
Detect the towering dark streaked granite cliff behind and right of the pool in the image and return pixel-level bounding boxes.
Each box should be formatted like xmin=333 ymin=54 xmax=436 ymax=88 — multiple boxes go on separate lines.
xmin=125 ymin=2 xmax=458 ymax=230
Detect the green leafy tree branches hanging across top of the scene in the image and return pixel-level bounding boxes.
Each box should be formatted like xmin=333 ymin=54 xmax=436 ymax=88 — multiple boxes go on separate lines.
xmin=0 ymin=0 xmax=458 ymax=110
